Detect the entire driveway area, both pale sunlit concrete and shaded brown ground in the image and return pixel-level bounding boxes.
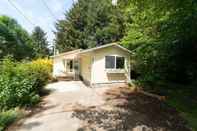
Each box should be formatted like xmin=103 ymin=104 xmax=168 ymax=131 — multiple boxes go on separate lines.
xmin=8 ymin=81 xmax=191 ymax=131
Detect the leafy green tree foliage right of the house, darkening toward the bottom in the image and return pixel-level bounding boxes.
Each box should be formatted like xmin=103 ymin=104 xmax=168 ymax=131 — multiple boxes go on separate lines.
xmin=122 ymin=0 xmax=197 ymax=83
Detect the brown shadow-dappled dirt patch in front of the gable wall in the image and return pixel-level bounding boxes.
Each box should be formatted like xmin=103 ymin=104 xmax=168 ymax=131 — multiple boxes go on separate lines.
xmin=72 ymin=88 xmax=190 ymax=131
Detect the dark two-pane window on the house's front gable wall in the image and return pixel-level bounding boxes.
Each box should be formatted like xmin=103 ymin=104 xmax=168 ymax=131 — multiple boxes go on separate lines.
xmin=105 ymin=56 xmax=125 ymax=69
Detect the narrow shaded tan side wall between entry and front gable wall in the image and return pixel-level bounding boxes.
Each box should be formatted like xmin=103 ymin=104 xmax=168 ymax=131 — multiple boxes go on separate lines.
xmin=80 ymin=54 xmax=92 ymax=85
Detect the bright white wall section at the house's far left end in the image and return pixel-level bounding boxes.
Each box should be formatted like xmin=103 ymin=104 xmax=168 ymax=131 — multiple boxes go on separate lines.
xmin=53 ymin=56 xmax=66 ymax=77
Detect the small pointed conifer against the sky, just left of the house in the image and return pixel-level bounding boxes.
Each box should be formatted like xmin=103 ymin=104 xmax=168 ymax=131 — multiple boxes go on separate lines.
xmin=32 ymin=26 xmax=50 ymax=57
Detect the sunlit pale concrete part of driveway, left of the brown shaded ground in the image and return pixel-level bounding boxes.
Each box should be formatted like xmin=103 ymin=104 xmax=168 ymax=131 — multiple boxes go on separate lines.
xmin=9 ymin=81 xmax=107 ymax=131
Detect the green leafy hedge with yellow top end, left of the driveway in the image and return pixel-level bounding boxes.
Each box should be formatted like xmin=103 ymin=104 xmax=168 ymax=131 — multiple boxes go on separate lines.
xmin=0 ymin=58 xmax=51 ymax=110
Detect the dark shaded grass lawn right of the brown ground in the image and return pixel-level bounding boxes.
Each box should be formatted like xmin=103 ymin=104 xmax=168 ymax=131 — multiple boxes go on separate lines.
xmin=145 ymin=84 xmax=197 ymax=131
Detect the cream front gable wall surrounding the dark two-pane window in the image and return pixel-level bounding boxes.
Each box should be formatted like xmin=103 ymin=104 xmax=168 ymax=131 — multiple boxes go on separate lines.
xmin=91 ymin=47 xmax=130 ymax=84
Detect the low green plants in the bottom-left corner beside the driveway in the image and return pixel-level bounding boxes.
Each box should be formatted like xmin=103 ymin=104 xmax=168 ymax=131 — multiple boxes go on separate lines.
xmin=0 ymin=109 xmax=22 ymax=131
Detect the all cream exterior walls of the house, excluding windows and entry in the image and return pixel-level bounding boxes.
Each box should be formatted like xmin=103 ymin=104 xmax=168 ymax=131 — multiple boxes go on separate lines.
xmin=53 ymin=46 xmax=130 ymax=84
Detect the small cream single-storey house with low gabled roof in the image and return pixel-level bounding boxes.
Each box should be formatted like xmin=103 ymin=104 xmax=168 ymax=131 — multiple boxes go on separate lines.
xmin=53 ymin=43 xmax=131 ymax=85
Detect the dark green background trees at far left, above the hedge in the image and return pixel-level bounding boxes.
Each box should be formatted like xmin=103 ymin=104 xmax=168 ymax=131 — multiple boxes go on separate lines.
xmin=0 ymin=16 xmax=50 ymax=60
